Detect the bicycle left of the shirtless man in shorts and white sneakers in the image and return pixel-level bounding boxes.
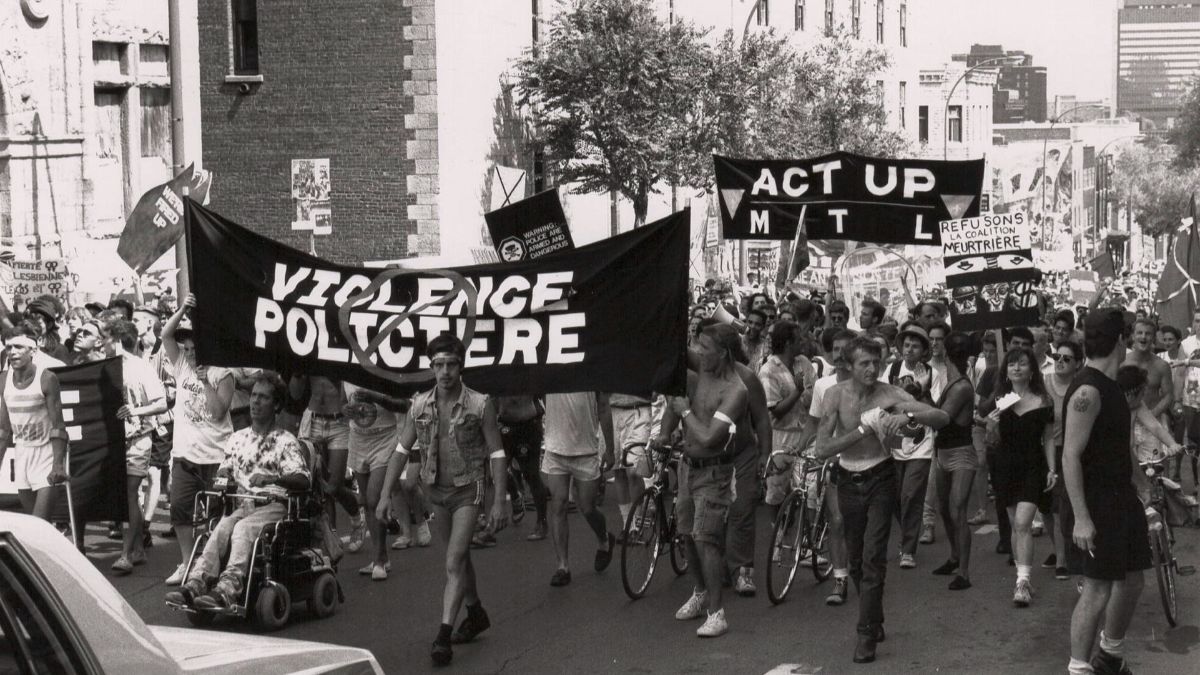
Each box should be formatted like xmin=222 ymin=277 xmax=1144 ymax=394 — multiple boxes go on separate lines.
xmin=620 ymin=446 xmax=688 ymax=601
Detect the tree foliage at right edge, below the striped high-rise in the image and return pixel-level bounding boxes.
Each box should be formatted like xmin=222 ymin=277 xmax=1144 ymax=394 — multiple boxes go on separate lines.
xmin=1112 ymin=145 xmax=1200 ymax=234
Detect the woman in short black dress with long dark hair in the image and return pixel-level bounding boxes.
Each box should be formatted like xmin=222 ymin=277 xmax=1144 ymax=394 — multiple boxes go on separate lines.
xmin=988 ymin=348 xmax=1058 ymax=607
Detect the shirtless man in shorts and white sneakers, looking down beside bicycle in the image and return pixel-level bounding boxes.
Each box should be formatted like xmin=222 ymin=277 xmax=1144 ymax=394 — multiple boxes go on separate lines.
xmin=658 ymin=324 xmax=748 ymax=638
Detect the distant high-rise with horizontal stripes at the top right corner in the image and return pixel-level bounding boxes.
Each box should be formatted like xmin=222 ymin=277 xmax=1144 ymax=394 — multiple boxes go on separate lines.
xmin=1117 ymin=0 xmax=1200 ymax=129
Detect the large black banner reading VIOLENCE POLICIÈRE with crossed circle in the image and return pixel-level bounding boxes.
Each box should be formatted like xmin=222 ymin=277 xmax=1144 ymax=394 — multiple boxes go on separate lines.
xmin=186 ymin=201 xmax=690 ymax=394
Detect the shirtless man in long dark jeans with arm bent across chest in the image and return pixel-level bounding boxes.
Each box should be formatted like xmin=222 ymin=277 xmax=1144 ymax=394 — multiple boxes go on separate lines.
xmin=816 ymin=338 xmax=950 ymax=663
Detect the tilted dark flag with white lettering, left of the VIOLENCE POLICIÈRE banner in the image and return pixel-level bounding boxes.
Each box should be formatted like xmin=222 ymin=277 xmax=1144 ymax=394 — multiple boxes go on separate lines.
xmin=116 ymin=165 xmax=212 ymax=274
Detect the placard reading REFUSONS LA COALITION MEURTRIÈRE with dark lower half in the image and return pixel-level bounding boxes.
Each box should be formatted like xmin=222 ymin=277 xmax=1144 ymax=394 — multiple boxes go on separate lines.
xmin=940 ymin=213 xmax=1042 ymax=330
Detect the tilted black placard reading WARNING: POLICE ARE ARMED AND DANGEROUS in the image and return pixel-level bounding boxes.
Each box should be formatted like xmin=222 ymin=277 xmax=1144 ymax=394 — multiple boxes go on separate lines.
xmin=484 ymin=189 xmax=575 ymax=263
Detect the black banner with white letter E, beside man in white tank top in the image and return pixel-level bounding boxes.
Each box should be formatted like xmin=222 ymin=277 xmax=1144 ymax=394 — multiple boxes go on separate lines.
xmin=49 ymin=357 xmax=128 ymax=522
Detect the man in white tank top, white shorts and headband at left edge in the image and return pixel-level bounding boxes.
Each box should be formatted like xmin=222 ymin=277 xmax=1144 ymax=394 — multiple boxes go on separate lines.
xmin=0 ymin=322 xmax=67 ymax=520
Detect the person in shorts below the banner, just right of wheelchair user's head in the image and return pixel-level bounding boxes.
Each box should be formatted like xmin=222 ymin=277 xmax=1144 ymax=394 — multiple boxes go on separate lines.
xmin=289 ymin=375 xmax=366 ymax=552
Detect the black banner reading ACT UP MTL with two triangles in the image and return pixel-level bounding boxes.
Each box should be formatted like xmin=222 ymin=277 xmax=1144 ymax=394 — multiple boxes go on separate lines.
xmin=713 ymin=153 xmax=984 ymax=245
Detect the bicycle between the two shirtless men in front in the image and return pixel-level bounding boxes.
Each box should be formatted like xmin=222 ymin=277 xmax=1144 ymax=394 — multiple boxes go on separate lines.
xmin=767 ymin=449 xmax=833 ymax=604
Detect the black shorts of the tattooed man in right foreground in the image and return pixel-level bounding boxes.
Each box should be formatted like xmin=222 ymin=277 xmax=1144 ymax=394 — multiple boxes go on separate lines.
xmin=1079 ymin=485 xmax=1152 ymax=581
